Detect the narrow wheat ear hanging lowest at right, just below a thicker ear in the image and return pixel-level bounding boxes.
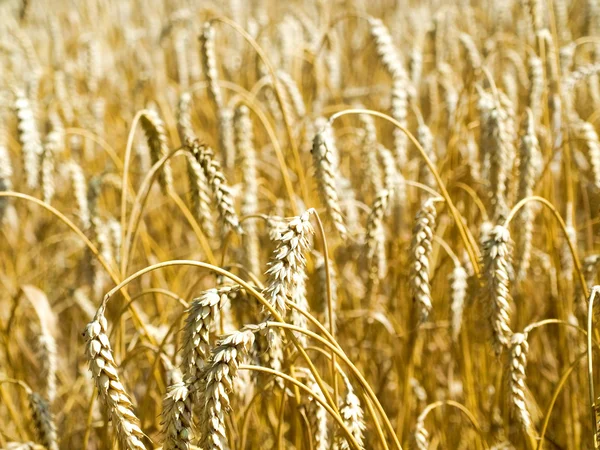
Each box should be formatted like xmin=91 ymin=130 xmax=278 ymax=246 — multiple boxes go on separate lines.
xmin=507 ymin=333 xmax=533 ymax=434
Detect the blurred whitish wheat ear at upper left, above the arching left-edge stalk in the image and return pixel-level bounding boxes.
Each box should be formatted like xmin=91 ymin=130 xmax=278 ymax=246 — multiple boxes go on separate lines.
xmin=15 ymin=90 xmax=44 ymax=189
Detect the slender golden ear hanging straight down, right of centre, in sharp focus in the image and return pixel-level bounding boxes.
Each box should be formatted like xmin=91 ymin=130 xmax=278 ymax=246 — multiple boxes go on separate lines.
xmin=410 ymin=198 xmax=437 ymax=323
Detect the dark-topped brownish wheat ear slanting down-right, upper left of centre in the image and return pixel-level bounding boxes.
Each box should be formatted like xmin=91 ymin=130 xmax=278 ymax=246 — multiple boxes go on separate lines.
xmin=186 ymin=139 xmax=243 ymax=234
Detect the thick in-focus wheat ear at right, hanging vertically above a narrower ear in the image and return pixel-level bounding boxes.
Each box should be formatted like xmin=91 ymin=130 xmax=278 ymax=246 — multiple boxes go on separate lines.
xmin=482 ymin=225 xmax=512 ymax=354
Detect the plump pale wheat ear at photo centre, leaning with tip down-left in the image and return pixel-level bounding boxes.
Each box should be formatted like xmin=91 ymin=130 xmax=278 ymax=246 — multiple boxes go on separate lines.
xmin=263 ymin=209 xmax=314 ymax=316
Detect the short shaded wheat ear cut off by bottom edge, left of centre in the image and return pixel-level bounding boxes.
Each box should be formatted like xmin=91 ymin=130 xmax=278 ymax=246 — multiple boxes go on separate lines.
xmin=162 ymin=381 xmax=193 ymax=450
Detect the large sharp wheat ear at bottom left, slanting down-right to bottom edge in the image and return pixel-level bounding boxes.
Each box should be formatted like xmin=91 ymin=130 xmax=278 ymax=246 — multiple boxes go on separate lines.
xmin=83 ymin=310 xmax=146 ymax=450
